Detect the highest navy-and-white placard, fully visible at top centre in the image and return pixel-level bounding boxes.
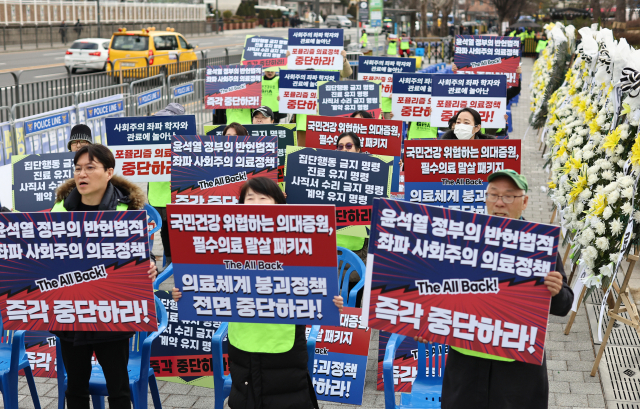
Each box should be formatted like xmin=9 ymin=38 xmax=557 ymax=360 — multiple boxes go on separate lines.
xmin=287 ymin=28 xmax=344 ymax=71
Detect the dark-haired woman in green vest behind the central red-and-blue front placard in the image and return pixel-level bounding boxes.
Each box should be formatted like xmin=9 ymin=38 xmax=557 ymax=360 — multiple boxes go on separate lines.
xmin=172 ymin=177 xmax=343 ymax=409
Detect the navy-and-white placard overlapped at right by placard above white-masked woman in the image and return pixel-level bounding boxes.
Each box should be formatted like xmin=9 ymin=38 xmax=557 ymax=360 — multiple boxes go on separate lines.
xmin=391 ymin=73 xmax=433 ymax=122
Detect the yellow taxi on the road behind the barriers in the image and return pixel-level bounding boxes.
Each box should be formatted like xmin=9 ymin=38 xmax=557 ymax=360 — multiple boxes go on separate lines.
xmin=107 ymin=27 xmax=198 ymax=71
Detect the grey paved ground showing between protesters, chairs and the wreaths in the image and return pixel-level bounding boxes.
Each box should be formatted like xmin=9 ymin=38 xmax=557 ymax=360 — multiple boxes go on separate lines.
xmin=3 ymin=55 xmax=616 ymax=409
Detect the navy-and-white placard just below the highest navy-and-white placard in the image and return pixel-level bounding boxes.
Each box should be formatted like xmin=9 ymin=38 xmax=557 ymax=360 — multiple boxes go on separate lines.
xmin=278 ymin=70 xmax=340 ymax=115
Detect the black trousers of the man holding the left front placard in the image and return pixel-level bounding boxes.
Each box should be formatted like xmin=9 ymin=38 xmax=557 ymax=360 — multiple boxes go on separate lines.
xmin=60 ymin=339 xmax=131 ymax=409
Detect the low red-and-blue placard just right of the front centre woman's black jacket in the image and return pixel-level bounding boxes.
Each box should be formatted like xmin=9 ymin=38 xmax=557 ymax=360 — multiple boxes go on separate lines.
xmin=307 ymin=307 xmax=371 ymax=405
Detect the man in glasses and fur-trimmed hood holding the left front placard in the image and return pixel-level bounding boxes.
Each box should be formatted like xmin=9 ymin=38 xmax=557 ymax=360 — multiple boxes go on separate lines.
xmin=51 ymin=145 xmax=158 ymax=409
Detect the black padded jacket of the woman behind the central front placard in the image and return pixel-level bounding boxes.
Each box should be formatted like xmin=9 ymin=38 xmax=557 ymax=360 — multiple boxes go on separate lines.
xmin=229 ymin=325 xmax=318 ymax=409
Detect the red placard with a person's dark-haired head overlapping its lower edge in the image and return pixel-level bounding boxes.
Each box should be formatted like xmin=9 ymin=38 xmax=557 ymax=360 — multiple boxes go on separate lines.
xmin=306 ymin=116 xmax=402 ymax=156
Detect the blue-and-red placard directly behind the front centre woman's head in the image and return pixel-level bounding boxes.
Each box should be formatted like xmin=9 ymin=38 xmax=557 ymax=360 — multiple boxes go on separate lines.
xmin=171 ymin=135 xmax=278 ymax=204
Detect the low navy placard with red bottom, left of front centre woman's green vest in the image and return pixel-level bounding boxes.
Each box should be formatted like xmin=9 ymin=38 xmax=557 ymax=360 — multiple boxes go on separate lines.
xmin=151 ymin=291 xmax=229 ymax=388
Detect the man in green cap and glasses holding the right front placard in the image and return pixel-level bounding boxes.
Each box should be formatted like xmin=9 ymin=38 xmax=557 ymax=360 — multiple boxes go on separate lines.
xmin=414 ymin=169 xmax=574 ymax=409
